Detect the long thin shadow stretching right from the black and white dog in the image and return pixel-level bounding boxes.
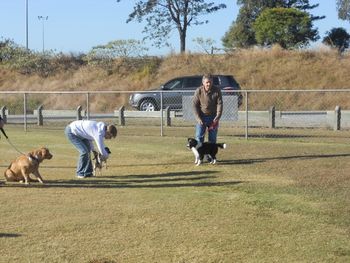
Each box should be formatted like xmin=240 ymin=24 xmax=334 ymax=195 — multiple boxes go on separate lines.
xmin=218 ymin=153 xmax=350 ymax=164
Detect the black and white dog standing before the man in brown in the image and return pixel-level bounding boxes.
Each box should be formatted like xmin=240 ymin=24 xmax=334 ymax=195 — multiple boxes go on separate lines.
xmin=187 ymin=138 xmax=226 ymax=166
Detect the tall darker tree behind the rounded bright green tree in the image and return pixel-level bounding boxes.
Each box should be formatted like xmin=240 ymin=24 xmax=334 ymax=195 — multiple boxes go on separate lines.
xmin=222 ymin=0 xmax=324 ymax=48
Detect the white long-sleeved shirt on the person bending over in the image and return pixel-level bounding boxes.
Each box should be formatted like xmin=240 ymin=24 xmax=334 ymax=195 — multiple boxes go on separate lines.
xmin=69 ymin=120 xmax=108 ymax=159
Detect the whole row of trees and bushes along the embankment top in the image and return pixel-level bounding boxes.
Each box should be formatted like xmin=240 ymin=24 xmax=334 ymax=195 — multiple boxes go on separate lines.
xmin=0 ymin=0 xmax=350 ymax=67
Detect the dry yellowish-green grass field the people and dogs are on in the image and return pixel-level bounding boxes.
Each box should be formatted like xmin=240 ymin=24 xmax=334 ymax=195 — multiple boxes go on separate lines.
xmin=0 ymin=127 xmax=350 ymax=263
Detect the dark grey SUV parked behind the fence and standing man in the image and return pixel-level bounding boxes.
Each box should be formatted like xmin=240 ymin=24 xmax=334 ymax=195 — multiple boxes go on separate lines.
xmin=129 ymin=75 xmax=242 ymax=111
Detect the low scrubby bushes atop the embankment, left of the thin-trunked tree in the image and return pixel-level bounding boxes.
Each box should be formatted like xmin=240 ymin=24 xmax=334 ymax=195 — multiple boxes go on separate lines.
xmin=0 ymin=39 xmax=161 ymax=77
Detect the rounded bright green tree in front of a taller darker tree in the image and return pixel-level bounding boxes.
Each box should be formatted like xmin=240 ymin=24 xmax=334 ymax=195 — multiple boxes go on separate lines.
xmin=253 ymin=8 xmax=318 ymax=49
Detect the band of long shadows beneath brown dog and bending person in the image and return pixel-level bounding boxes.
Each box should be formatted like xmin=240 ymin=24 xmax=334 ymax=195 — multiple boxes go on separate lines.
xmin=3 ymin=171 xmax=241 ymax=188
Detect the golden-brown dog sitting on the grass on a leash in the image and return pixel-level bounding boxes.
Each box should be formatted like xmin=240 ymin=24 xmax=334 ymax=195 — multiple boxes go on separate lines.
xmin=4 ymin=147 xmax=52 ymax=184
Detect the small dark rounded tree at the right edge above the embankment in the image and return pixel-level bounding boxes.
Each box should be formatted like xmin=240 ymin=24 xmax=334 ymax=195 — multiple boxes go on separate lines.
xmin=322 ymin=27 xmax=350 ymax=53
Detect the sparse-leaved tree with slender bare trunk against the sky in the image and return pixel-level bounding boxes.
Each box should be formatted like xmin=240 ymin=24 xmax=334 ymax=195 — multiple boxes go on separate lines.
xmin=117 ymin=0 xmax=226 ymax=52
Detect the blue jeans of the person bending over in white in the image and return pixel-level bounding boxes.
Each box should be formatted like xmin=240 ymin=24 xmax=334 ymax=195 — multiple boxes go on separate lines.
xmin=64 ymin=126 xmax=93 ymax=177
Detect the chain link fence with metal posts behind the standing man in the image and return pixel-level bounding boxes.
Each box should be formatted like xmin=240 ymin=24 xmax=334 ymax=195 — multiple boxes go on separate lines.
xmin=0 ymin=89 xmax=350 ymax=138
